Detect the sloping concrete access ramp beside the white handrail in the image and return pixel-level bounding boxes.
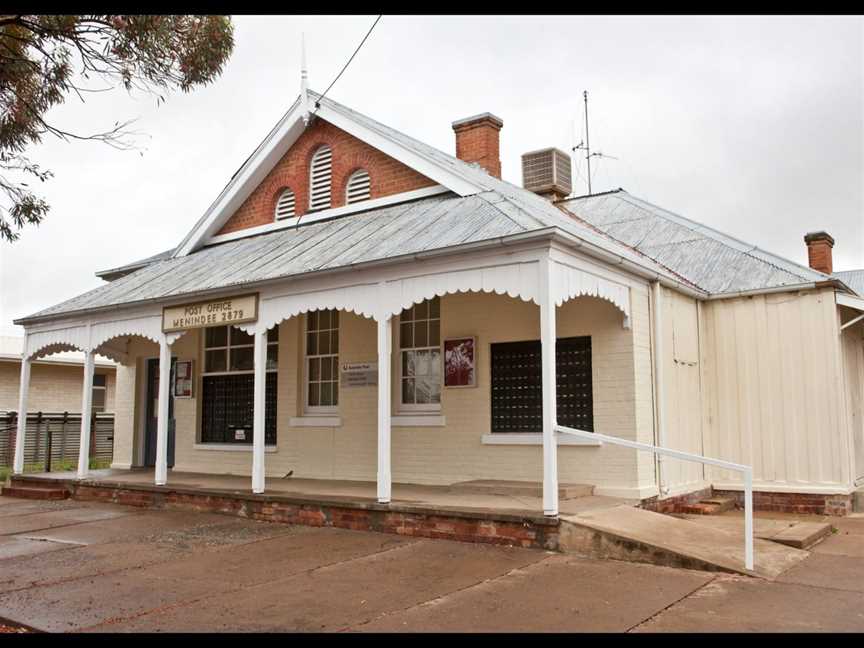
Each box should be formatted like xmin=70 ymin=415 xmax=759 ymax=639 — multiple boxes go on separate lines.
xmin=559 ymin=506 xmax=809 ymax=579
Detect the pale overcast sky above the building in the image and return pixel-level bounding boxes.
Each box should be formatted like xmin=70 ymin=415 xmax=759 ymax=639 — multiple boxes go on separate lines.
xmin=0 ymin=15 xmax=864 ymax=334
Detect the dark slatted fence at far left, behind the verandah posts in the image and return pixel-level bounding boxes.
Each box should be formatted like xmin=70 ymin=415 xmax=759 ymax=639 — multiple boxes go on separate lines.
xmin=0 ymin=411 xmax=114 ymax=472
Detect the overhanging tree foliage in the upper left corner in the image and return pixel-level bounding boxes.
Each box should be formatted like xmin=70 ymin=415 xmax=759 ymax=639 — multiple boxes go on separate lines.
xmin=0 ymin=14 xmax=234 ymax=241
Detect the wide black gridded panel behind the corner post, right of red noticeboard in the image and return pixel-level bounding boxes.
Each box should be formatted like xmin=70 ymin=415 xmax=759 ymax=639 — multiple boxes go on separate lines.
xmin=490 ymin=337 xmax=594 ymax=433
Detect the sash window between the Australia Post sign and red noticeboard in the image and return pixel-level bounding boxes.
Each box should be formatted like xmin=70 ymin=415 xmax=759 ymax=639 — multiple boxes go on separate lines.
xmin=399 ymin=297 xmax=442 ymax=410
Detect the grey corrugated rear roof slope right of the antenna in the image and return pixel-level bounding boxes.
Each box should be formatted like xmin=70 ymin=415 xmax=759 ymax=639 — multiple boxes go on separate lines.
xmin=559 ymin=189 xmax=830 ymax=294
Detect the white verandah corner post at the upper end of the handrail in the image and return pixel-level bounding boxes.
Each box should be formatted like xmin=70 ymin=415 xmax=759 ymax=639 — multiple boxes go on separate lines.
xmin=539 ymin=256 xmax=558 ymax=515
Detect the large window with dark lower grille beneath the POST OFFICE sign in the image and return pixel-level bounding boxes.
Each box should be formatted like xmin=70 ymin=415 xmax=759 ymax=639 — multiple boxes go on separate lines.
xmin=201 ymin=326 xmax=279 ymax=445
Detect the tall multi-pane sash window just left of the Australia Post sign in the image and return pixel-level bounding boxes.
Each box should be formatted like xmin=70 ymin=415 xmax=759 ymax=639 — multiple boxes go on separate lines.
xmin=306 ymin=310 xmax=339 ymax=412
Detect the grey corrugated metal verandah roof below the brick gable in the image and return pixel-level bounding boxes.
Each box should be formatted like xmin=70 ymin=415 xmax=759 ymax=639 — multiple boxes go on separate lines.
xmin=21 ymin=191 xmax=680 ymax=321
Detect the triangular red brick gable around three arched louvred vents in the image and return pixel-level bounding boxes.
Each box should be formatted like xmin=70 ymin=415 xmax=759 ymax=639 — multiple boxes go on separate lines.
xmin=217 ymin=119 xmax=437 ymax=234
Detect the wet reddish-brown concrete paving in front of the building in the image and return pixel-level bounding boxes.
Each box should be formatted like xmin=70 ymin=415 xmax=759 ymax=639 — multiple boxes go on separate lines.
xmin=0 ymin=497 xmax=864 ymax=632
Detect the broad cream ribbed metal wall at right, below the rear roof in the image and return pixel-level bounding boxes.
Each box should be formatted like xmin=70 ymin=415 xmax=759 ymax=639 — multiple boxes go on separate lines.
xmin=701 ymin=289 xmax=851 ymax=492
